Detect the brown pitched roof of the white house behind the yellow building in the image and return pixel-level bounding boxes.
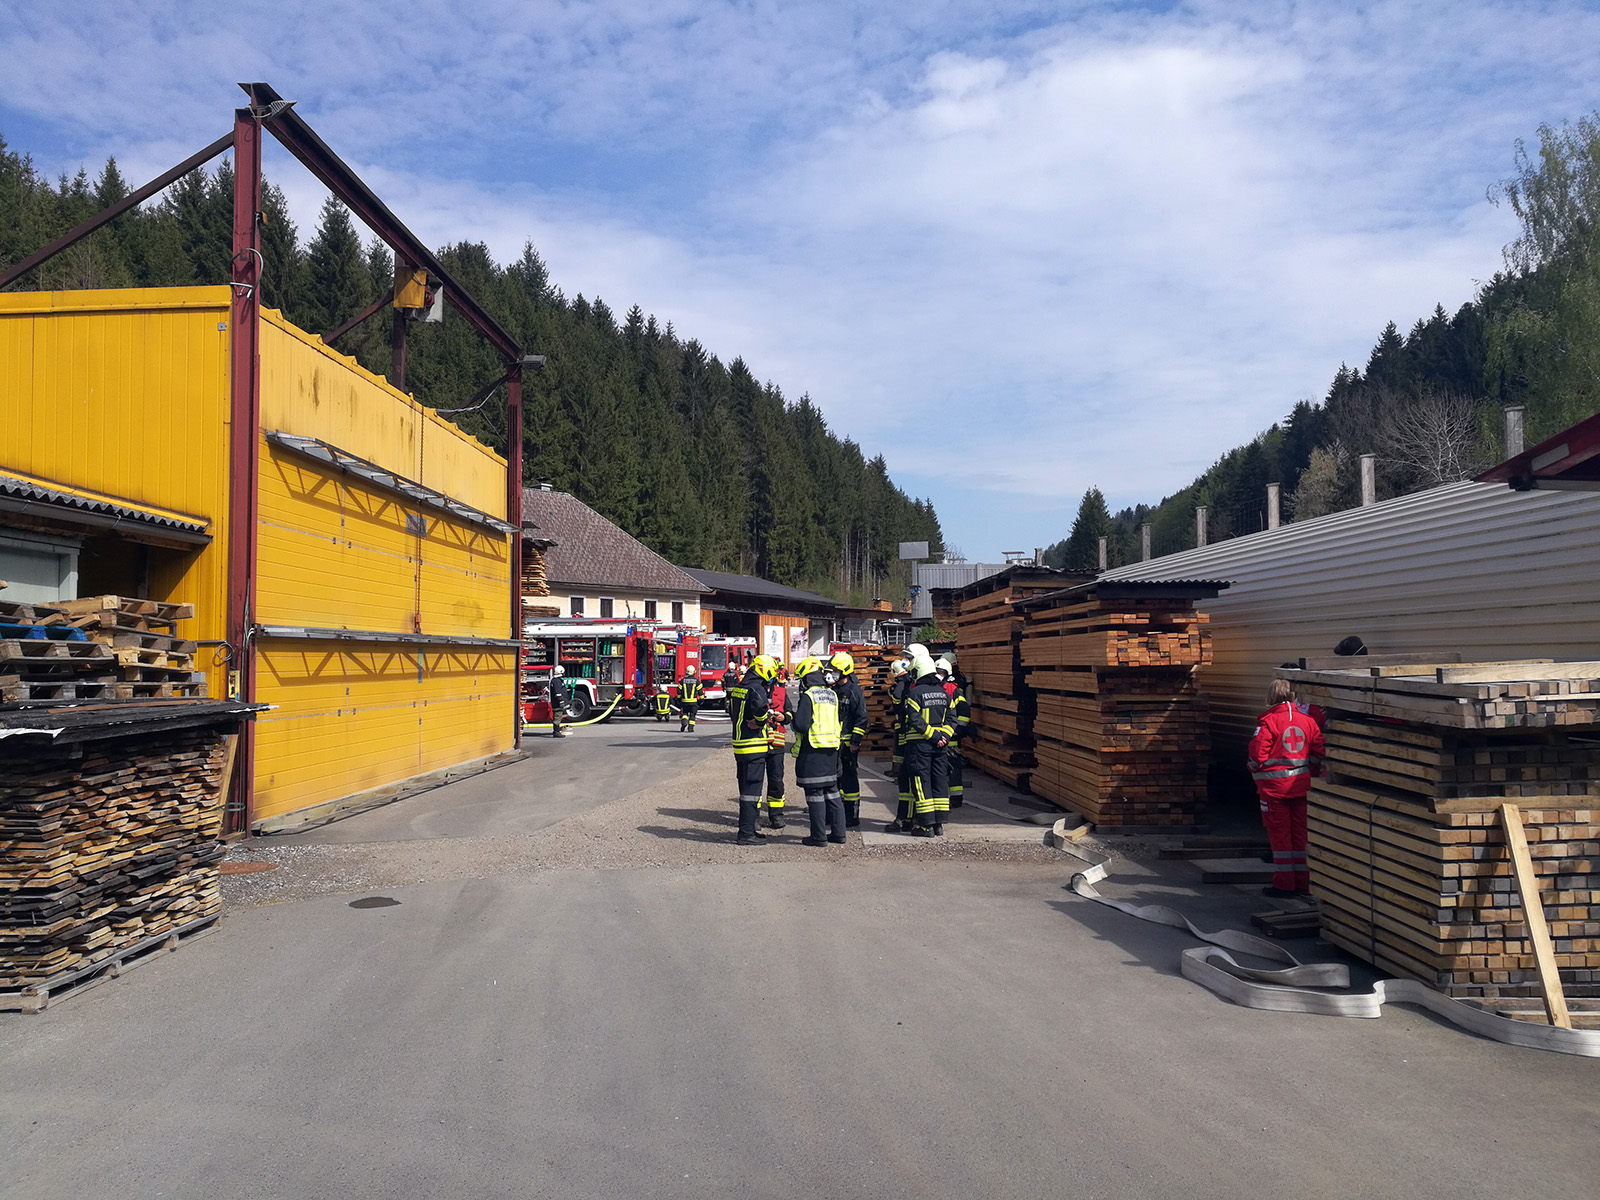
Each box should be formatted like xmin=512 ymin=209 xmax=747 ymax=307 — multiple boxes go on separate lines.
xmin=522 ymin=488 xmax=706 ymax=595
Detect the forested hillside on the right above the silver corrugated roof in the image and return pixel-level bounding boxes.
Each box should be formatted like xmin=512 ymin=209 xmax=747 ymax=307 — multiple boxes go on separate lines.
xmin=1045 ymin=115 xmax=1600 ymax=570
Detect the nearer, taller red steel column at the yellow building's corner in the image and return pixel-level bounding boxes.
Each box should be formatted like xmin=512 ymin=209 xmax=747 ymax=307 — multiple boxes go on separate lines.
xmin=227 ymin=109 xmax=261 ymax=832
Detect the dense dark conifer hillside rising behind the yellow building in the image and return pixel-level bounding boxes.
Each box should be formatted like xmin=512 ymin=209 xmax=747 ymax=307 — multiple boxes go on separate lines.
xmin=0 ymin=141 xmax=942 ymax=603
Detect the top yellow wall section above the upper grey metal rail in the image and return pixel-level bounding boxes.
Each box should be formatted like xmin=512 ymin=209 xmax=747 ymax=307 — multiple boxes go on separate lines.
xmin=261 ymin=309 xmax=506 ymax=520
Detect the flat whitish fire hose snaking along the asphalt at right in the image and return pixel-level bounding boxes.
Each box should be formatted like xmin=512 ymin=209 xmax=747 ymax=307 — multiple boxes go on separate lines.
xmin=1051 ymin=818 xmax=1600 ymax=1058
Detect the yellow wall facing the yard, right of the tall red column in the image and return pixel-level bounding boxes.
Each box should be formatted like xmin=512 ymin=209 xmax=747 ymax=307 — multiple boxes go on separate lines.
xmin=254 ymin=312 xmax=517 ymax=819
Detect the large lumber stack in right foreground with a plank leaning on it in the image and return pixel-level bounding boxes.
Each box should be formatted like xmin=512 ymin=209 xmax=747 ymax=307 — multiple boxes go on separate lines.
xmin=1280 ymin=662 xmax=1600 ymax=1002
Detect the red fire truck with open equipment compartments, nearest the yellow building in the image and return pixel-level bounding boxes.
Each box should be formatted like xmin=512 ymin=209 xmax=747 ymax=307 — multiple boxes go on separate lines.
xmin=522 ymin=616 xmax=699 ymax=722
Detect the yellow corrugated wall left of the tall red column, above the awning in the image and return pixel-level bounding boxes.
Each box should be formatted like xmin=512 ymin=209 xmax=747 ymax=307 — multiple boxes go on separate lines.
xmin=0 ymin=286 xmax=229 ymax=678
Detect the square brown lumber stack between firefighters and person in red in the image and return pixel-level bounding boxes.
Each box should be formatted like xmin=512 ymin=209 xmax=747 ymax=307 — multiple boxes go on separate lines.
xmin=1021 ymin=590 xmax=1211 ymax=829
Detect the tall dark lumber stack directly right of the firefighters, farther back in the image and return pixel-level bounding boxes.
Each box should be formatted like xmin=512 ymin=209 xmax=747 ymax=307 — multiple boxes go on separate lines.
xmin=955 ymin=582 xmax=1059 ymax=787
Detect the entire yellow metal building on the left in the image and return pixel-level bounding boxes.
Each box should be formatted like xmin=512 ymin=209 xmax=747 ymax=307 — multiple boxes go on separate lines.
xmin=0 ymin=286 xmax=517 ymax=824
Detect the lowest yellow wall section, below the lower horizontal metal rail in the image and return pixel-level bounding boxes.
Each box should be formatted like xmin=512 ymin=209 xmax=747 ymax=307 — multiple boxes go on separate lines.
xmin=254 ymin=640 xmax=517 ymax=819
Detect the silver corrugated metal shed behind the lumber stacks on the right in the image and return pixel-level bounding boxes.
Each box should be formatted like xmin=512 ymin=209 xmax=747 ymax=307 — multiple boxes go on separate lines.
xmin=1104 ymin=483 xmax=1600 ymax=755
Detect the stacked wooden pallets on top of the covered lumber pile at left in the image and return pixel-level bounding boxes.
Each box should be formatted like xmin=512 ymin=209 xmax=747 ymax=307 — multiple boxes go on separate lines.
xmin=0 ymin=595 xmax=205 ymax=704
